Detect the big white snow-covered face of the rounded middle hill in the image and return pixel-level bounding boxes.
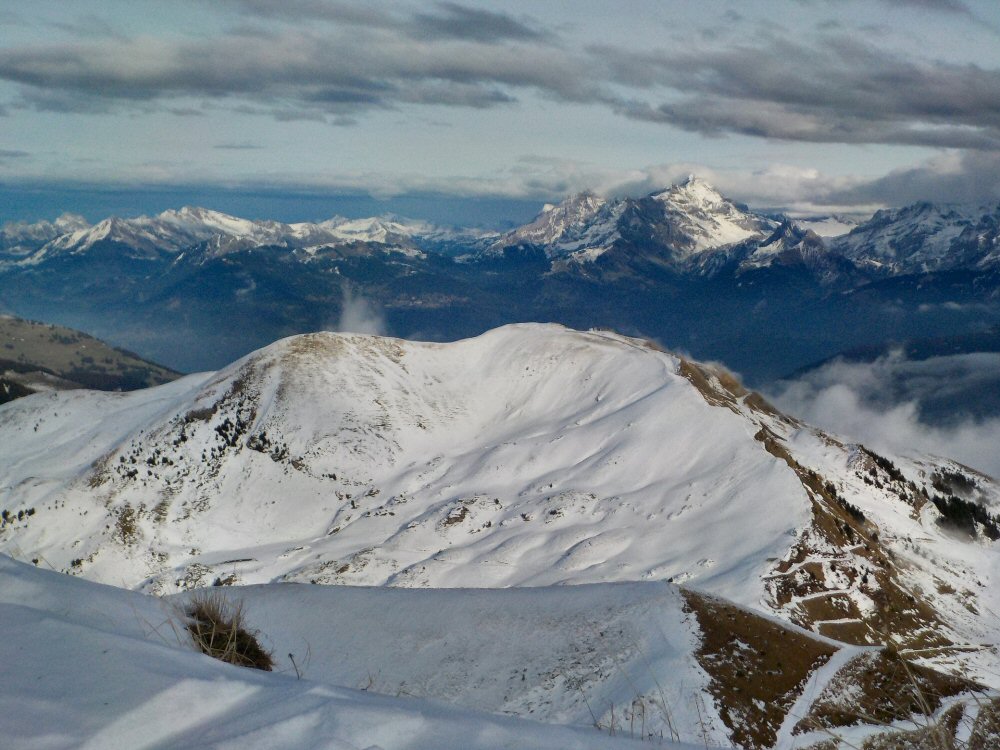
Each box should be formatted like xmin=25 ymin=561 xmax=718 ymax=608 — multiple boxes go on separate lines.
xmin=0 ymin=325 xmax=808 ymax=602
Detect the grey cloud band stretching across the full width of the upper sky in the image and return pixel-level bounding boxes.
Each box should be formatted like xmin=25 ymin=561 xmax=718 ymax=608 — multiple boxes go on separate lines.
xmin=0 ymin=0 xmax=1000 ymax=150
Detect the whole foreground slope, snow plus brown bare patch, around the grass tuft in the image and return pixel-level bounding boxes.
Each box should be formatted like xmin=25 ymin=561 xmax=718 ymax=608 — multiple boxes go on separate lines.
xmin=0 ymin=556 xmax=981 ymax=750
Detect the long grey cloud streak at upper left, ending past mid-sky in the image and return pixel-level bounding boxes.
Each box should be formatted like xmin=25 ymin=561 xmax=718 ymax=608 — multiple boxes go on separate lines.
xmin=0 ymin=23 xmax=598 ymax=117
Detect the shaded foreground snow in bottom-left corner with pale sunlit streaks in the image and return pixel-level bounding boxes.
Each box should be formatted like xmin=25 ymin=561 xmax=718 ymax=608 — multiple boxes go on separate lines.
xmin=0 ymin=556 xmax=680 ymax=750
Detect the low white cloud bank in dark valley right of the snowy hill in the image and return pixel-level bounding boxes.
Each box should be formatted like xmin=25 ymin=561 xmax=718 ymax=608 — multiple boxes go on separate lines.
xmin=766 ymin=352 xmax=1000 ymax=477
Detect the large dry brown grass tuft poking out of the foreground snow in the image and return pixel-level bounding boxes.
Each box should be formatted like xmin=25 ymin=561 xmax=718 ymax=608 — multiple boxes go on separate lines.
xmin=185 ymin=591 xmax=274 ymax=672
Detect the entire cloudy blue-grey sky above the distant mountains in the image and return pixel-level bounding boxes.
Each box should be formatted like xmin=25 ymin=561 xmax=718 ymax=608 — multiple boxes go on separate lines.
xmin=0 ymin=0 xmax=1000 ymax=224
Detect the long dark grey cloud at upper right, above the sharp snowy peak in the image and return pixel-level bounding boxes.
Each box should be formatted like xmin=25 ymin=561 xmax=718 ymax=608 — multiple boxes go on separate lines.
xmin=603 ymin=35 xmax=1000 ymax=149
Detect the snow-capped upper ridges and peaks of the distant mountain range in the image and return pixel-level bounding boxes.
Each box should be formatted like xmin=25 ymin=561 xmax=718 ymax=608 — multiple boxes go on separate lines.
xmin=11 ymin=181 xmax=1000 ymax=281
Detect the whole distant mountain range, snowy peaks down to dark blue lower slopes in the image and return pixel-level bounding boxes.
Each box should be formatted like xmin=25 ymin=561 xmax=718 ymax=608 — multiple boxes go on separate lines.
xmin=0 ymin=177 xmax=1000 ymax=382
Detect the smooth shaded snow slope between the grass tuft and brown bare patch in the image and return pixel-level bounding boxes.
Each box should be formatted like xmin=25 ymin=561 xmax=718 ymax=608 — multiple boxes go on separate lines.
xmin=181 ymin=583 xmax=729 ymax=743
